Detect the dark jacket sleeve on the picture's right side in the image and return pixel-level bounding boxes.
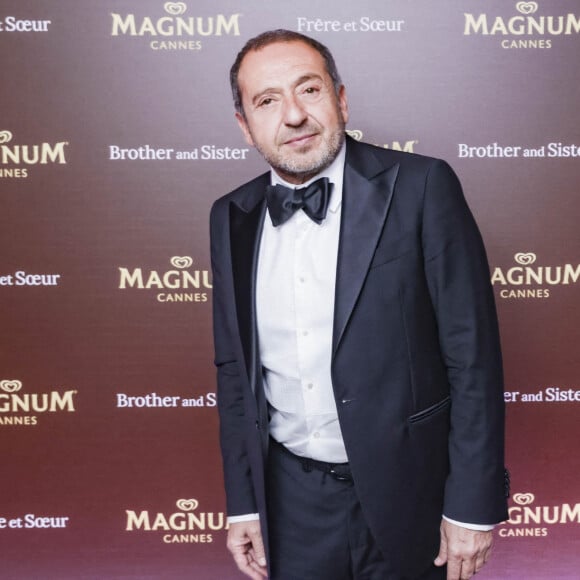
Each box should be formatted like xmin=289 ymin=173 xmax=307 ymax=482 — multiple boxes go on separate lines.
xmin=422 ymin=161 xmax=507 ymax=524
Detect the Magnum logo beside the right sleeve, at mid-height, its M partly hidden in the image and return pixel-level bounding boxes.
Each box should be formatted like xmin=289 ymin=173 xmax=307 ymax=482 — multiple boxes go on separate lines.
xmin=491 ymin=252 xmax=580 ymax=298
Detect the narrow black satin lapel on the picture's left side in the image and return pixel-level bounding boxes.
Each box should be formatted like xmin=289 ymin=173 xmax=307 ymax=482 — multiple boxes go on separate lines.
xmin=230 ymin=180 xmax=268 ymax=390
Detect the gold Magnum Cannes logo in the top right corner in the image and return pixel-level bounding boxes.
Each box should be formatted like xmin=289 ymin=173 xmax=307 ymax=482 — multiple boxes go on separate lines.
xmin=463 ymin=2 xmax=580 ymax=49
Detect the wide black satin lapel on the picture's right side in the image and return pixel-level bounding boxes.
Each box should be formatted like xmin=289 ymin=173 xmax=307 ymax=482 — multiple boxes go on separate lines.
xmin=332 ymin=157 xmax=399 ymax=354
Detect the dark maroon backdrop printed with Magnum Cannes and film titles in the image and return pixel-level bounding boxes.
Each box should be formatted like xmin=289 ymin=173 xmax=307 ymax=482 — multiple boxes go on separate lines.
xmin=0 ymin=0 xmax=580 ymax=580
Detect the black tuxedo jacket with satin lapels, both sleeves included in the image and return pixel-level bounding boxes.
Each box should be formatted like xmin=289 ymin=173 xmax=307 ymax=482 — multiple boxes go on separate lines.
xmin=211 ymin=139 xmax=507 ymax=577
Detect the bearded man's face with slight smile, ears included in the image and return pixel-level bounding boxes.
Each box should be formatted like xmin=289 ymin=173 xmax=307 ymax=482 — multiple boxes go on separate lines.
xmin=236 ymin=41 xmax=348 ymax=184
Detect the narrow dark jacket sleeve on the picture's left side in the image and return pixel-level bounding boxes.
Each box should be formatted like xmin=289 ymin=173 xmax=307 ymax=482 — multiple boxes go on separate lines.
xmin=210 ymin=200 xmax=257 ymax=516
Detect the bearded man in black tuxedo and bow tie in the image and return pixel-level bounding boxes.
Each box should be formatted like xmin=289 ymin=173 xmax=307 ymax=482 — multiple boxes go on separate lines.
xmin=210 ymin=30 xmax=507 ymax=580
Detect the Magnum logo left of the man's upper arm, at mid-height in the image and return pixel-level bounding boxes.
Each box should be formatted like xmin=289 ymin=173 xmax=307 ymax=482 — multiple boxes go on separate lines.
xmin=119 ymin=256 xmax=212 ymax=302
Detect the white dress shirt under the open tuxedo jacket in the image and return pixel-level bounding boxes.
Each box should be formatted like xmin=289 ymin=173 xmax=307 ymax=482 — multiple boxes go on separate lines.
xmin=256 ymin=146 xmax=348 ymax=463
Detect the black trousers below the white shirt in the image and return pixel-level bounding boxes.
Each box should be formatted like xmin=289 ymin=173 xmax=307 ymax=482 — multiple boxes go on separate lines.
xmin=267 ymin=441 xmax=446 ymax=580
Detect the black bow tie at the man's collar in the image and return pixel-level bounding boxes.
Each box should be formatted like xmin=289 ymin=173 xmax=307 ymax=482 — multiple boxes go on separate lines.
xmin=266 ymin=177 xmax=333 ymax=226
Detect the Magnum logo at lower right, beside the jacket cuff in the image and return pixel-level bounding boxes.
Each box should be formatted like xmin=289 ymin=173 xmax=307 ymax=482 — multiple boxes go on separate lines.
xmin=499 ymin=493 xmax=580 ymax=538
